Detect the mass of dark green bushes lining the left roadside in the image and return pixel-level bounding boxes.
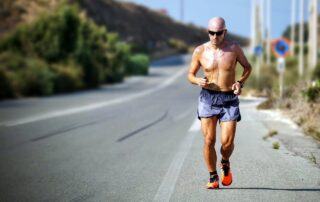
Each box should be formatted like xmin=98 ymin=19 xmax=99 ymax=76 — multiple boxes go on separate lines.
xmin=0 ymin=3 xmax=149 ymax=99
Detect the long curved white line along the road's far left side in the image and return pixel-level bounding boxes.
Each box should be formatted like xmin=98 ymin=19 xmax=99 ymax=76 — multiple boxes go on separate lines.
xmin=0 ymin=68 xmax=187 ymax=126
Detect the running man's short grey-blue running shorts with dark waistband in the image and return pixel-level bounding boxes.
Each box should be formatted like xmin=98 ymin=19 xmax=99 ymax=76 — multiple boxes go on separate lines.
xmin=197 ymin=88 xmax=241 ymax=121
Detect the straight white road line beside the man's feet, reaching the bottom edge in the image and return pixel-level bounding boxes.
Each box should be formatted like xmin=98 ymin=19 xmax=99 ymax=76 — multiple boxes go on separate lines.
xmin=153 ymin=118 xmax=200 ymax=201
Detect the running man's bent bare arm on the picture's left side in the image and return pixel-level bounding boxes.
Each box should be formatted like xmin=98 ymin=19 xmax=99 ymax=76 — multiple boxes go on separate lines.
xmin=188 ymin=47 xmax=208 ymax=87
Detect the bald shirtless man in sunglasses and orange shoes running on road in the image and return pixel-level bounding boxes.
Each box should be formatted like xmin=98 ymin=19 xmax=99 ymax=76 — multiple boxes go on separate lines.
xmin=188 ymin=17 xmax=251 ymax=189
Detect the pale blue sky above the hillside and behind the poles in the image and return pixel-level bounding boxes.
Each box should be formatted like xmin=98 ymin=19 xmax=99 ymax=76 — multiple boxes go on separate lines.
xmin=119 ymin=0 xmax=319 ymax=38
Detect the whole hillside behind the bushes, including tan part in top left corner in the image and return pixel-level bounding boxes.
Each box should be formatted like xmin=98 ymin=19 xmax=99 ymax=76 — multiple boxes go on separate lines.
xmin=0 ymin=0 xmax=248 ymax=56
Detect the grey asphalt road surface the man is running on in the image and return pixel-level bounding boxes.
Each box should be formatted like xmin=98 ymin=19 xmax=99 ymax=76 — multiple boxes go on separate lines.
xmin=0 ymin=57 xmax=320 ymax=202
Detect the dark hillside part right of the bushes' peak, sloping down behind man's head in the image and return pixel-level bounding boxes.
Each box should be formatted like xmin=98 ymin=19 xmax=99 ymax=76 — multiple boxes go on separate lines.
xmin=80 ymin=0 xmax=246 ymax=51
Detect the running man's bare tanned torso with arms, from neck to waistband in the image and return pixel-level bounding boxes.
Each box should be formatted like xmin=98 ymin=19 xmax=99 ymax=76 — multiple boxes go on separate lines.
xmin=189 ymin=41 xmax=250 ymax=91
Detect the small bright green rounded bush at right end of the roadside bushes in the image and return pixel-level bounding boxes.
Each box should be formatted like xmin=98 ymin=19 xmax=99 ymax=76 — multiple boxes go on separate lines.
xmin=127 ymin=54 xmax=150 ymax=75
